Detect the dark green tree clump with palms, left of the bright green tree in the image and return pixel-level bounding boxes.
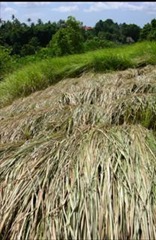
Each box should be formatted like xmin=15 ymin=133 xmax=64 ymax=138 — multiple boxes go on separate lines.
xmin=0 ymin=18 xmax=58 ymax=56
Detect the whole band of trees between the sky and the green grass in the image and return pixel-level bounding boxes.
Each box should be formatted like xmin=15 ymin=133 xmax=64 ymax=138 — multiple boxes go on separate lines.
xmin=0 ymin=15 xmax=156 ymax=57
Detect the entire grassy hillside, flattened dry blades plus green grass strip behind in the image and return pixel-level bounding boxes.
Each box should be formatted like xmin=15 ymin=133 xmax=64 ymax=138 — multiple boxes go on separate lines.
xmin=0 ymin=62 xmax=156 ymax=240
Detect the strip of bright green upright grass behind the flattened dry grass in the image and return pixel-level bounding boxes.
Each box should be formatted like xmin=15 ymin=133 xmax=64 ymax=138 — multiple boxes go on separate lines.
xmin=0 ymin=42 xmax=156 ymax=107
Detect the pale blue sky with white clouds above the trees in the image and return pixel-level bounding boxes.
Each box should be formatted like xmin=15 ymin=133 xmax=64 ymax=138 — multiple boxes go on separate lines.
xmin=0 ymin=1 xmax=156 ymax=27
